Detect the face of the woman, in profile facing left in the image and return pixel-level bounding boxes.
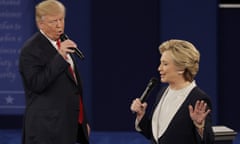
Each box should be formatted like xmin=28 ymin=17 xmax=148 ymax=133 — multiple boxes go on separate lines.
xmin=158 ymin=51 xmax=183 ymax=84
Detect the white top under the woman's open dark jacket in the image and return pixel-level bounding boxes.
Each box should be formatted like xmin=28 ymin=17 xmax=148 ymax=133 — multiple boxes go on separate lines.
xmin=152 ymin=81 xmax=196 ymax=141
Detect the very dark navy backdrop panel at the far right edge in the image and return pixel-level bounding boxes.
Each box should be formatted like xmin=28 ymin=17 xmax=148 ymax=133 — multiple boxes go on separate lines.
xmin=218 ymin=3 xmax=240 ymax=131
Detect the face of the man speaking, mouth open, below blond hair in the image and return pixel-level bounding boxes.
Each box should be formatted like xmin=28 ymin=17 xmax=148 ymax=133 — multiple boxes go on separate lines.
xmin=38 ymin=14 xmax=65 ymax=40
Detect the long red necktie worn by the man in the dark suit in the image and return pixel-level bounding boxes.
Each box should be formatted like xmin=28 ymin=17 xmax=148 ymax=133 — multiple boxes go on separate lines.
xmin=57 ymin=40 xmax=83 ymax=124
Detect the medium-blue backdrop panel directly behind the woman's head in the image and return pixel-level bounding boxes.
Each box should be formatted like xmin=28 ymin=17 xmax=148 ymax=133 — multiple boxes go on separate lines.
xmin=160 ymin=0 xmax=218 ymax=124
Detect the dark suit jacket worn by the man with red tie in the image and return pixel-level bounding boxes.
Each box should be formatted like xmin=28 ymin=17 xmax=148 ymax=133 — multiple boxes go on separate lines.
xmin=19 ymin=32 xmax=88 ymax=144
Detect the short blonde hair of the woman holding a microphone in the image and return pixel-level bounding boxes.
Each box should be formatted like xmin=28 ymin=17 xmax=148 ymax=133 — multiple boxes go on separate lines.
xmin=159 ymin=39 xmax=200 ymax=82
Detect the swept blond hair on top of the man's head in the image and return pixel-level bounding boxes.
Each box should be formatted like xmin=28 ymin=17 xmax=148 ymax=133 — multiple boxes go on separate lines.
xmin=35 ymin=0 xmax=65 ymax=22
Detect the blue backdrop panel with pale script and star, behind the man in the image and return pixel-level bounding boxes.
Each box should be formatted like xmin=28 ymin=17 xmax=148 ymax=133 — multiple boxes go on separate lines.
xmin=0 ymin=0 xmax=35 ymax=115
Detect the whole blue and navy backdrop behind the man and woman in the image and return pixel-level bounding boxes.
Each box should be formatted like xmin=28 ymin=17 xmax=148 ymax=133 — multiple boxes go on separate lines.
xmin=0 ymin=0 xmax=237 ymax=131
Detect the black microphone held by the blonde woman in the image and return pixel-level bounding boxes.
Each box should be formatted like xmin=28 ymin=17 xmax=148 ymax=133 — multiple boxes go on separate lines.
xmin=140 ymin=77 xmax=158 ymax=102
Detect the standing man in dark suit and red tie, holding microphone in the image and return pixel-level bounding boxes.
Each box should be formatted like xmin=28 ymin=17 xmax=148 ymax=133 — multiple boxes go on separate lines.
xmin=19 ymin=0 xmax=90 ymax=144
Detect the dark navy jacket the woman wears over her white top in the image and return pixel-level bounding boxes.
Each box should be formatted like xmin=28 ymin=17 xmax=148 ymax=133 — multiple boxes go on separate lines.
xmin=139 ymin=87 xmax=214 ymax=144
